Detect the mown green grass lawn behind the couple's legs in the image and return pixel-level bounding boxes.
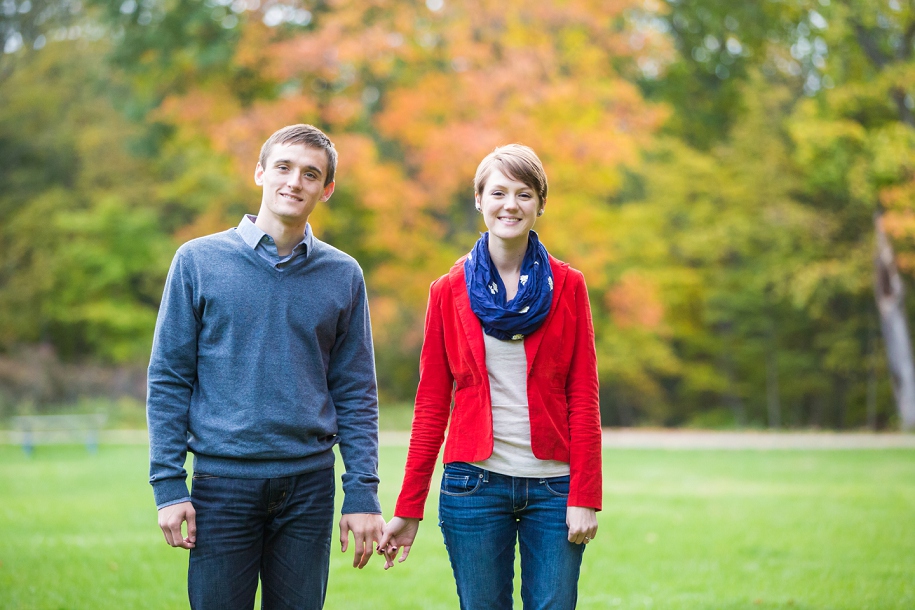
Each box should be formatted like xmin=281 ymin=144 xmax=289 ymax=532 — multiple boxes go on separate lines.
xmin=0 ymin=446 xmax=915 ymax=610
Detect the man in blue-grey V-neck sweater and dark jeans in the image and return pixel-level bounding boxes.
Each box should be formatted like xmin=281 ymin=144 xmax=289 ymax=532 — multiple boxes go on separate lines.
xmin=147 ymin=125 xmax=384 ymax=610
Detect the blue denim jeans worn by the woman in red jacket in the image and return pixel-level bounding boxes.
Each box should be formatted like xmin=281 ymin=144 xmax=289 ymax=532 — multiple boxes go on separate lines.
xmin=439 ymin=462 xmax=585 ymax=610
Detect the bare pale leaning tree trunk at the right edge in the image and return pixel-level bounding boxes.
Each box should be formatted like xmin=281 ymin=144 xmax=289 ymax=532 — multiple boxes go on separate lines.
xmin=874 ymin=214 xmax=915 ymax=430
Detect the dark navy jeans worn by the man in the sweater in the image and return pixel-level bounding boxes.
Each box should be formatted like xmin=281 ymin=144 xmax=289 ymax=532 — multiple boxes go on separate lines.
xmin=187 ymin=468 xmax=335 ymax=610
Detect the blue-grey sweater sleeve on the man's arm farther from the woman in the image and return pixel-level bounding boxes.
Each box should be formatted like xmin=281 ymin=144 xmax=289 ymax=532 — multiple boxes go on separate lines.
xmin=146 ymin=249 xmax=200 ymax=508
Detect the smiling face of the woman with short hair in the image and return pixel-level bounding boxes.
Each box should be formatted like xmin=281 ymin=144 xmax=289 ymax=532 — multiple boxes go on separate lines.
xmin=476 ymin=169 xmax=541 ymax=243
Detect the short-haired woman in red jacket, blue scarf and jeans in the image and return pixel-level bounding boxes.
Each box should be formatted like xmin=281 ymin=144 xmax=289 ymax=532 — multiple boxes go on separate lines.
xmin=379 ymin=144 xmax=601 ymax=610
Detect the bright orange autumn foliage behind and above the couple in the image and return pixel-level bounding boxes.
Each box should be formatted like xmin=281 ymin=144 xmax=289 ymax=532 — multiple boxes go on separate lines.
xmin=154 ymin=0 xmax=665 ymax=356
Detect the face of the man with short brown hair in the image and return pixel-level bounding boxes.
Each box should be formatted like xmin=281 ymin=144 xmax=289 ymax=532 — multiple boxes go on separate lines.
xmin=254 ymin=144 xmax=334 ymax=225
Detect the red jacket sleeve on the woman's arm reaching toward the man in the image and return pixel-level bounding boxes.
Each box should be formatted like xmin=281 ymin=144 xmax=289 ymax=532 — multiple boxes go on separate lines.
xmin=394 ymin=278 xmax=454 ymax=519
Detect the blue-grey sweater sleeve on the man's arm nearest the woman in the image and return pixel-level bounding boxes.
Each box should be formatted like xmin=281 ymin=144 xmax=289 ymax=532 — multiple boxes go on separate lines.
xmin=327 ymin=270 xmax=381 ymax=514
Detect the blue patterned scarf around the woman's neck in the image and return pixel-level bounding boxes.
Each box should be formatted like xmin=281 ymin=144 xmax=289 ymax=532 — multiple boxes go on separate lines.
xmin=464 ymin=231 xmax=553 ymax=341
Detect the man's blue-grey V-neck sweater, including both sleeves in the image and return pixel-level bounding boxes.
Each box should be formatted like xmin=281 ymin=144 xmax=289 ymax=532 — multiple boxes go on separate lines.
xmin=147 ymin=228 xmax=381 ymax=513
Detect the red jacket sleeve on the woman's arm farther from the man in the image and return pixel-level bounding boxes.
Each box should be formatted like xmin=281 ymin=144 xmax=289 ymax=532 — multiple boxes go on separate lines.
xmin=566 ymin=271 xmax=603 ymax=510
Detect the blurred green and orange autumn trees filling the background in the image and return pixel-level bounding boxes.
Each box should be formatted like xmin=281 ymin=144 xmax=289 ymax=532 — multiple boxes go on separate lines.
xmin=0 ymin=0 xmax=915 ymax=428
